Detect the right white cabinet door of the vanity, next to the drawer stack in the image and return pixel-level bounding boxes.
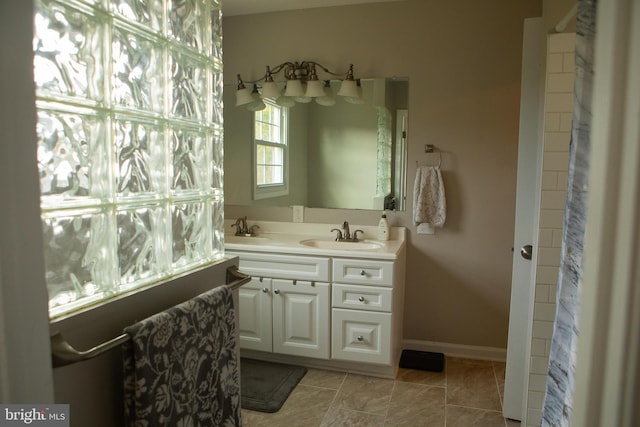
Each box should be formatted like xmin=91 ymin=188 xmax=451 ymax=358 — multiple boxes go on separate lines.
xmin=273 ymin=279 xmax=331 ymax=359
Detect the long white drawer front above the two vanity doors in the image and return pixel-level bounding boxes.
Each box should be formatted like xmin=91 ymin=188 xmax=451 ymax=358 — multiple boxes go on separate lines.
xmin=227 ymin=251 xmax=329 ymax=282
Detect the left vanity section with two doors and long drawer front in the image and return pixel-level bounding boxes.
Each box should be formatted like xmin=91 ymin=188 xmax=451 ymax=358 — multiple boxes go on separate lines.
xmin=231 ymin=252 xmax=331 ymax=359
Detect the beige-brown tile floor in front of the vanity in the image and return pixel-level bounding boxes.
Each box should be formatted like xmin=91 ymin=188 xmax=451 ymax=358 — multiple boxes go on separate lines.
xmin=242 ymin=357 xmax=520 ymax=427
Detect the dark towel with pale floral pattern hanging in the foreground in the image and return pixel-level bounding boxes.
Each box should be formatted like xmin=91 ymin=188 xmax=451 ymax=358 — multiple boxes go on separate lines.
xmin=123 ymin=286 xmax=241 ymax=427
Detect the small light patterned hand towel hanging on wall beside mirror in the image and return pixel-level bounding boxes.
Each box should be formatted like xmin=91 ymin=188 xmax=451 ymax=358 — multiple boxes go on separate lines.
xmin=413 ymin=166 xmax=447 ymax=228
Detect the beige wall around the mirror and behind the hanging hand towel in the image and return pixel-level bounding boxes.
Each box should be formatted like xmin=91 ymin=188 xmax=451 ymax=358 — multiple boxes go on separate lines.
xmin=223 ymin=0 xmax=542 ymax=348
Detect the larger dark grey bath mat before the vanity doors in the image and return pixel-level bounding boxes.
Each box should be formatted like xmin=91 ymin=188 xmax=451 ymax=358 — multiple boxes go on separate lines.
xmin=240 ymin=357 xmax=307 ymax=412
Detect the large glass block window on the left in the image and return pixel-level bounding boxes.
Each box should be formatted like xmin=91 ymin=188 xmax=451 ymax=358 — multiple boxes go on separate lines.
xmin=33 ymin=0 xmax=224 ymax=317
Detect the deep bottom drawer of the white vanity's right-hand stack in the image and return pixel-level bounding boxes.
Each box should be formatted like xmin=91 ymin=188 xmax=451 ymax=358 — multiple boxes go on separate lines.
xmin=331 ymin=308 xmax=391 ymax=364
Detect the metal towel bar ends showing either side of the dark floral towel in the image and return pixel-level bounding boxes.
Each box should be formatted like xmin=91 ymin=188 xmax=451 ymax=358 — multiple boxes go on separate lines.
xmin=51 ymin=265 xmax=251 ymax=368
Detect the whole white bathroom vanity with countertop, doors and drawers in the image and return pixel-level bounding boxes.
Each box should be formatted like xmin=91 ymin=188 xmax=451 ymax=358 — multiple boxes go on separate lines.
xmin=225 ymin=221 xmax=406 ymax=378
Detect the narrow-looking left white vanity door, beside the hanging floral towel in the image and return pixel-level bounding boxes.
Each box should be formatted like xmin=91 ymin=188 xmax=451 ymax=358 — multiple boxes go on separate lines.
xmin=238 ymin=278 xmax=272 ymax=351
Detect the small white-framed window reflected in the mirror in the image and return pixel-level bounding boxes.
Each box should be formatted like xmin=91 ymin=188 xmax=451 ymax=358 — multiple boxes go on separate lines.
xmin=254 ymin=100 xmax=288 ymax=199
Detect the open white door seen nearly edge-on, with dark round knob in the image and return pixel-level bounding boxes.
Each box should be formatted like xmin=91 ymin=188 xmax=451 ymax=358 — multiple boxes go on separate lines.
xmin=503 ymin=18 xmax=546 ymax=420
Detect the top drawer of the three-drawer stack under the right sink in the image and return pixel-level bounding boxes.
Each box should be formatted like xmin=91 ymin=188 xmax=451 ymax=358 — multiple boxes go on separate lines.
xmin=332 ymin=258 xmax=393 ymax=286
